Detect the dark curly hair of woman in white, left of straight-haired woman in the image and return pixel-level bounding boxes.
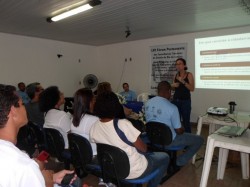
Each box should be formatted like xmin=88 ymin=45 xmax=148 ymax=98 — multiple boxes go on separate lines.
xmin=39 ymin=86 xmax=60 ymax=112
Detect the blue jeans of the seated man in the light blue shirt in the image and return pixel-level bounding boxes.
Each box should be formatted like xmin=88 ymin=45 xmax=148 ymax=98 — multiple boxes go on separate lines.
xmin=166 ymin=133 xmax=204 ymax=166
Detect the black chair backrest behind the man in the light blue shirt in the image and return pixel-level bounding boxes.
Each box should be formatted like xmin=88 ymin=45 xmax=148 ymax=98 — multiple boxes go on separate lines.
xmin=146 ymin=121 xmax=173 ymax=147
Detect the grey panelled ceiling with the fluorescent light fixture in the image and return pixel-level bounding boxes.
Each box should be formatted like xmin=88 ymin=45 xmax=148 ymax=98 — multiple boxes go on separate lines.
xmin=0 ymin=0 xmax=250 ymax=46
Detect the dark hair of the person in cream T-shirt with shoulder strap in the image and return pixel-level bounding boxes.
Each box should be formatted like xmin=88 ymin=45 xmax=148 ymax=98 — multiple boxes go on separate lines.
xmin=94 ymin=92 xmax=121 ymax=118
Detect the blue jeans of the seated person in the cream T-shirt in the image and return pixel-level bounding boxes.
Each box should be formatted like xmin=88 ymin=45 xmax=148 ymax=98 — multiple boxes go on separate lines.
xmin=138 ymin=152 xmax=169 ymax=187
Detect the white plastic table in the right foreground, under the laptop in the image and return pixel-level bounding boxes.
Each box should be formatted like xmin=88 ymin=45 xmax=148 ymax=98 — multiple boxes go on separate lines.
xmin=200 ymin=129 xmax=250 ymax=187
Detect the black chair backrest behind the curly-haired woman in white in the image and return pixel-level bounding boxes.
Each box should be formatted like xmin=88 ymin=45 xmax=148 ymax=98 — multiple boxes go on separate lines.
xmin=44 ymin=128 xmax=65 ymax=161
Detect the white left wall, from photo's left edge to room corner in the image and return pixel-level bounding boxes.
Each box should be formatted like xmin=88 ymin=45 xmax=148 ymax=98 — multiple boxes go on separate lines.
xmin=0 ymin=33 xmax=96 ymax=96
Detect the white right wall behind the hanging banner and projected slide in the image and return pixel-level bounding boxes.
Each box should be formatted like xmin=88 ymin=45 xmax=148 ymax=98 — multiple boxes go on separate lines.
xmin=98 ymin=27 xmax=250 ymax=122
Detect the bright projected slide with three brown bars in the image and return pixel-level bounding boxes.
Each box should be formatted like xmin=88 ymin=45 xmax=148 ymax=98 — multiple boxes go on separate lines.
xmin=195 ymin=33 xmax=250 ymax=90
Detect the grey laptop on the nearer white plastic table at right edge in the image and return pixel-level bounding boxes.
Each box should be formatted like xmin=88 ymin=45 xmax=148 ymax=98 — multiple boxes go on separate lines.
xmin=215 ymin=126 xmax=248 ymax=137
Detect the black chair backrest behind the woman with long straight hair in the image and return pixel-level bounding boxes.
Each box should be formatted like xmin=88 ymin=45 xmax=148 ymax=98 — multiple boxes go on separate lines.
xmin=68 ymin=133 xmax=93 ymax=178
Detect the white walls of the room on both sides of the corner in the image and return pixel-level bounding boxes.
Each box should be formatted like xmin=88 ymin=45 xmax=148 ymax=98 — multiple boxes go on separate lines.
xmin=0 ymin=27 xmax=250 ymax=122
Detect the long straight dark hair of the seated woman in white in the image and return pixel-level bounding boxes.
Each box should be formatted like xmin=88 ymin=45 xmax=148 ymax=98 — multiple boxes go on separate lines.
xmin=72 ymin=88 xmax=94 ymax=127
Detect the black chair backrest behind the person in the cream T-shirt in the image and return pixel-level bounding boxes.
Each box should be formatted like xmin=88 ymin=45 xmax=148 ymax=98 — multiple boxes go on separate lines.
xmin=97 ymin=143 xmax=130 ymax=183
